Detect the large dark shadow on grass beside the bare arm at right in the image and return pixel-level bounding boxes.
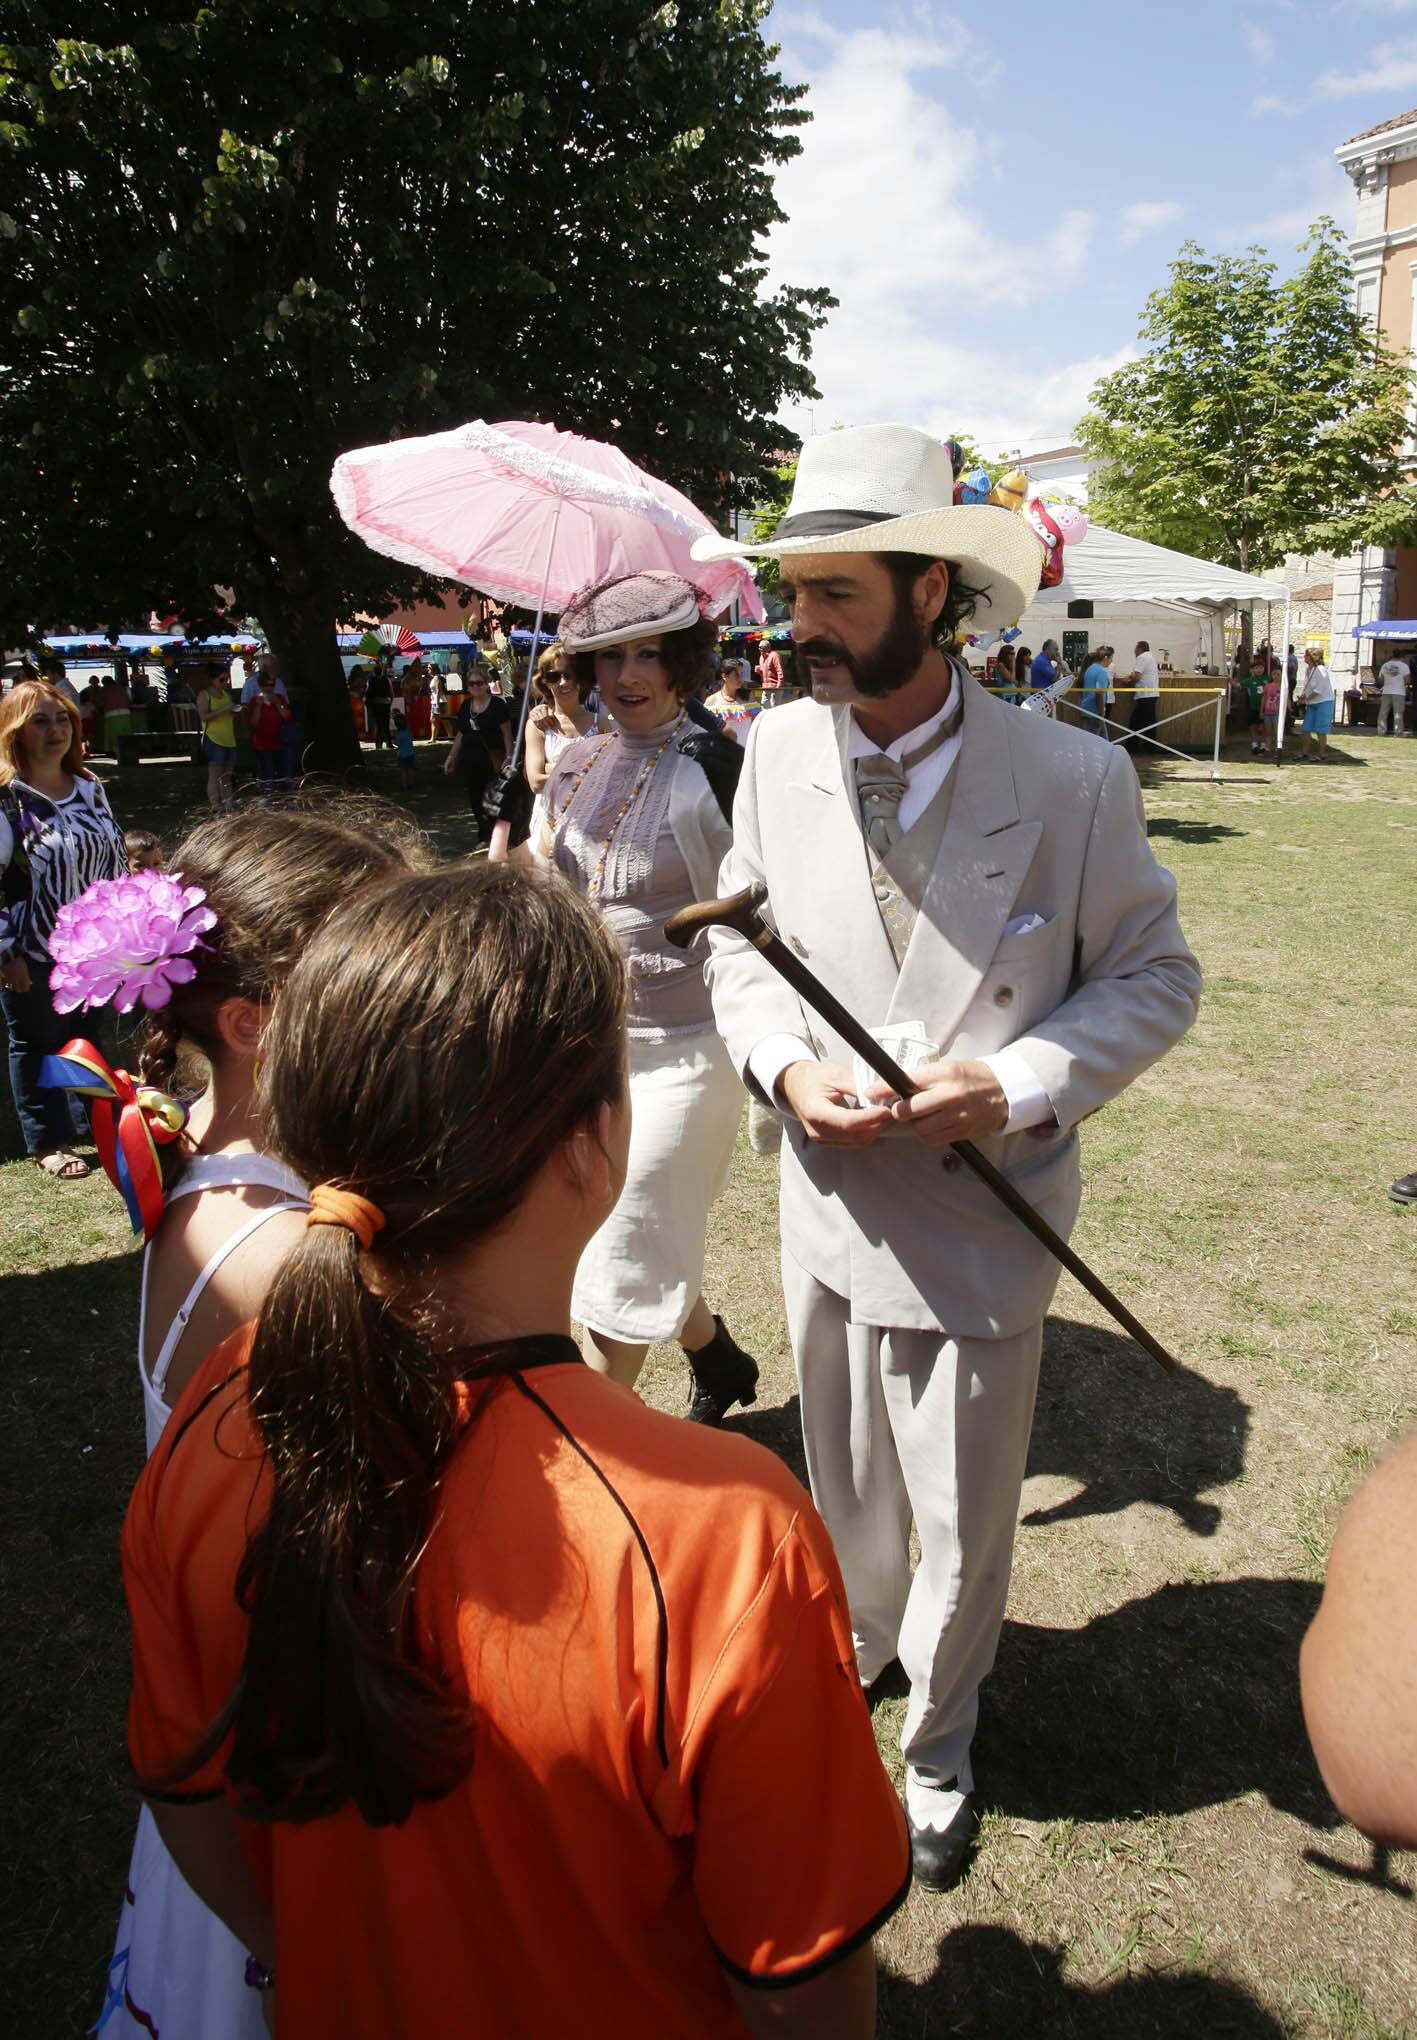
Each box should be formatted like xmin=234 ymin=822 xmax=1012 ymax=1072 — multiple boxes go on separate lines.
xmin=975 ymin=1579 xmax=1342 ymax=1830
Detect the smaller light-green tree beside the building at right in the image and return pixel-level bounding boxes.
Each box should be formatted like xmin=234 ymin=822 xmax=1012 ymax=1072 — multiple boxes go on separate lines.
xmin=1079 ymin=218 xmax=1417 ymax=573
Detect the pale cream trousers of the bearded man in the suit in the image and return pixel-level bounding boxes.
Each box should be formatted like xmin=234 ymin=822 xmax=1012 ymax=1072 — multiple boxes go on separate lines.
xmin=783 ymin=1251 xmax=1044 ymax=1785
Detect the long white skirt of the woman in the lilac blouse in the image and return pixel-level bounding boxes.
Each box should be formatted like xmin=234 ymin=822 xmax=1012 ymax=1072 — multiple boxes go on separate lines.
xmin=571 ymin=1034 xmax=744 ymax=1344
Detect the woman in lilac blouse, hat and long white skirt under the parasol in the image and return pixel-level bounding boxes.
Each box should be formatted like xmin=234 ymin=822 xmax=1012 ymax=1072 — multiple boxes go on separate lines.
xmin=532 ymin=571 xmax=758 ymax=1424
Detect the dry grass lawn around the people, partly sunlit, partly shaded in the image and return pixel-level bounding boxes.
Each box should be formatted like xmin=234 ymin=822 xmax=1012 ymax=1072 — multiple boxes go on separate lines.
xmin=0 ymin=732 xmax=1417 ymax=2040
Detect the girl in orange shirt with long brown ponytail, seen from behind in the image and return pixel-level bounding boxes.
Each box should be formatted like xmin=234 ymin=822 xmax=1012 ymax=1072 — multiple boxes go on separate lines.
xmin=122 ymin=863 xmax=909 ymax=2040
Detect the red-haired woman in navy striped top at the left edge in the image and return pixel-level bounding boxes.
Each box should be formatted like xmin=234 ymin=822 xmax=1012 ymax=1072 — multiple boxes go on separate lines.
xmin=0 ymin=681 xmax=128 ymax=1181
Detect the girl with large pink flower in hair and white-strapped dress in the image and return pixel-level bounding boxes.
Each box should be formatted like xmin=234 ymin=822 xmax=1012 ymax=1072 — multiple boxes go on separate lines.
xmin=51 ymin=806 xmax=422 ymax=2040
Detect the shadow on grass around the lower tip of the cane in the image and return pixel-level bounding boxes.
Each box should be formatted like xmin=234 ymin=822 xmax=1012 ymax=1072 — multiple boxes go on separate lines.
xmin=1024 ymin=1318 xmax=1250 ymax=1536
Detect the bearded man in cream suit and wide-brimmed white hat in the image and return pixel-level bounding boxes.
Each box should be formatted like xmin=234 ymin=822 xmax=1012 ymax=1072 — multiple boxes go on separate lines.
xmin=695 ymin=426 xmax=1201 ymax=1889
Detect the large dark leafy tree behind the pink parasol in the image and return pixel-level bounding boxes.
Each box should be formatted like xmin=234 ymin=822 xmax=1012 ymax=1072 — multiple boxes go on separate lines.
xmin=0 ymin=0 xmax=830 ymax=757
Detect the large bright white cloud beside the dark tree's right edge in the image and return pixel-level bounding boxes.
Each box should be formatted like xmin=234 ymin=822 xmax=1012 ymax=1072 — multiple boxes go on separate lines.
xmin=769 ymin=6 xmax=1121 ymax=449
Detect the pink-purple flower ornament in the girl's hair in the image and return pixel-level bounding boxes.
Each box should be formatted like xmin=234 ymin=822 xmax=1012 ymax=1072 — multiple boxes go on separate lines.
xmin=49 ymin=871 xmax=216 ymax=1014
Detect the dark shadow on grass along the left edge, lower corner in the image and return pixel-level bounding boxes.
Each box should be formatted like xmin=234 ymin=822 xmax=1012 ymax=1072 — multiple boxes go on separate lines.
xmin=0 ymin=1248 xmax=143 ymax=2036
